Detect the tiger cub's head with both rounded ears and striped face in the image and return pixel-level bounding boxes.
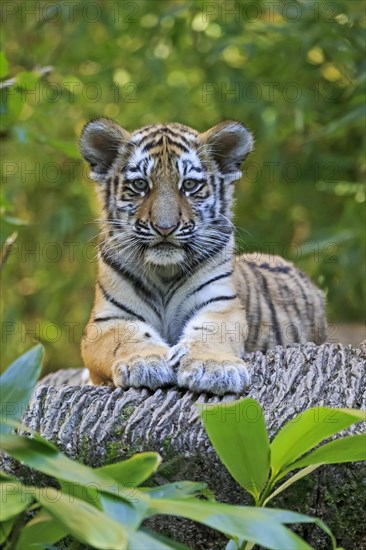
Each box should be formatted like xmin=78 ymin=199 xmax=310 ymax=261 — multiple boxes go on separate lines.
xmin=80 ymin=118 xmax=253 ymax=268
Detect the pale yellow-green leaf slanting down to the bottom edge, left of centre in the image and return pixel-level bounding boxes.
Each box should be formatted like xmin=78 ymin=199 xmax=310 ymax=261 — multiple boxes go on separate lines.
xmin=33 ymin=487 xmax=127 ymax=550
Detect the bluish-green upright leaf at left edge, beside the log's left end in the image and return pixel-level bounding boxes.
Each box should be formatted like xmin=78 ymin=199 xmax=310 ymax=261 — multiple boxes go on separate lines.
xmin=0 ymin=344 xmax=44 ymax=431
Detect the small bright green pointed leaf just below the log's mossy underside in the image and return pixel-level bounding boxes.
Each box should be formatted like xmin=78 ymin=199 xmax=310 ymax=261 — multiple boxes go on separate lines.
xmin=95 ymin=453 xmax=161 ymax=487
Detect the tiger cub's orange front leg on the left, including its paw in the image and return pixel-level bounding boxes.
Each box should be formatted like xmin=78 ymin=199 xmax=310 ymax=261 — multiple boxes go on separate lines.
xmin=82 ymin=320 xmax=176 ymax=389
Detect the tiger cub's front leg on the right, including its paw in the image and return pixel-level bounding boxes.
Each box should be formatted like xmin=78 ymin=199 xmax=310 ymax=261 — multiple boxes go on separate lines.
xmin=169 ymin=298 xmax=250 ymax=395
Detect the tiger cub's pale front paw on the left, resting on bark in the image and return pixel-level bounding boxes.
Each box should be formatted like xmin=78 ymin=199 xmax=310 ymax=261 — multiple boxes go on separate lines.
xmin=112 ymin=354 xmax=177 ymax=390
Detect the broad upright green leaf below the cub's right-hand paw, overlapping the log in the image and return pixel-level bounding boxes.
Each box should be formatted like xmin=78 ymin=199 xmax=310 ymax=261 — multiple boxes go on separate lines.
xmin=200 ymin=398 xmax=270 ymax=499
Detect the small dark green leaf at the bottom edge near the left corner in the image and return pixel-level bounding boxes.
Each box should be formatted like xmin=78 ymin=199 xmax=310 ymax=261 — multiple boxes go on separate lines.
xmin=16 ymin=510 xmax=68 ymax=550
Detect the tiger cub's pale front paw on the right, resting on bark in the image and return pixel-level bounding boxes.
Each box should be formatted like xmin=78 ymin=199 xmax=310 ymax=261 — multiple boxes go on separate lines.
xmin=173 ymin=354 xmax=250 ymax=395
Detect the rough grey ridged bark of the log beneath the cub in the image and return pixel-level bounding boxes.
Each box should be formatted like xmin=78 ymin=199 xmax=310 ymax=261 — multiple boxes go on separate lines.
xmin=2 ymin=342 xmax=366 ymax=549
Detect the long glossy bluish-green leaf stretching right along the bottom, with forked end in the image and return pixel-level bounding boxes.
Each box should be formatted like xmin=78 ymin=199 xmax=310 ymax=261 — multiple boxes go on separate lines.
xmin=149 ymin=499 xmax=316 ymax=550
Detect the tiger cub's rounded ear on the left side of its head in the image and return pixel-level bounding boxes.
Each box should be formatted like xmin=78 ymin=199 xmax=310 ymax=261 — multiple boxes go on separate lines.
xmin=79 ymin=118 xmax=131 ymax=182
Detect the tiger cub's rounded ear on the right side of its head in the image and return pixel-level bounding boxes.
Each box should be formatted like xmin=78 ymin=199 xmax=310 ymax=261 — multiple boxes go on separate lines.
xmin=200 ymin=120 xmax=254 ymax=179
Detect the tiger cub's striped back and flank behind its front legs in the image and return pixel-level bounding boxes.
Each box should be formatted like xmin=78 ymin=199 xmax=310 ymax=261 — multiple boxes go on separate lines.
xmin=234 ymin=253 xmax=327 ymax=351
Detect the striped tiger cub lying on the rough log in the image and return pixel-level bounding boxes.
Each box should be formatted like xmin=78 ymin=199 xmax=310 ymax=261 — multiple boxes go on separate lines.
xmin=80 ymin=118 xmax=326 ymax=395
